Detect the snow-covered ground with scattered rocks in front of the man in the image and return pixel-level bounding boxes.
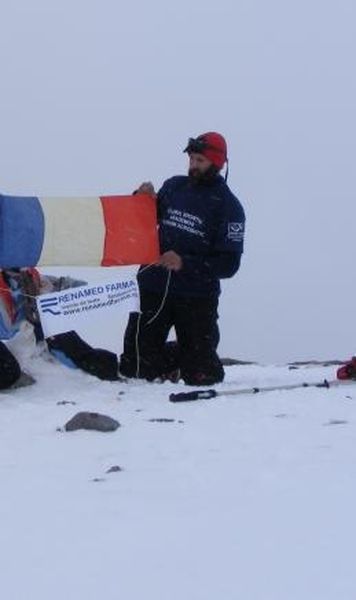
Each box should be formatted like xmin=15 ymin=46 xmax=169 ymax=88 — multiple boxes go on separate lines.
xmin=0 ymin=357 xmax=356 ymax=600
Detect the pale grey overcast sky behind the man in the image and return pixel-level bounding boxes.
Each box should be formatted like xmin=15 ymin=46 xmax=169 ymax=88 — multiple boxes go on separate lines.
xmin=0 ymin=0 xmax=356 ymax=362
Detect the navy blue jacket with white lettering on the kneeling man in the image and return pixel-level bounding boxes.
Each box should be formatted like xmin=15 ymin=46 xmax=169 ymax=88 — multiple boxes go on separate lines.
xmin=138 ymin=175 xmax=245 ymax=296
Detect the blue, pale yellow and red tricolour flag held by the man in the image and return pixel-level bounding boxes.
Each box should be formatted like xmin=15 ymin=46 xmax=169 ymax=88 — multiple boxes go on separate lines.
xmin=0 ymin=194 xmax=159 ymax=269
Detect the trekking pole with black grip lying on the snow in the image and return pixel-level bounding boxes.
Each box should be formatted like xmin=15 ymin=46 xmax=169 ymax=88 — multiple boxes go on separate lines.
xmin=169 ymin=379 xmax=356 ymax=402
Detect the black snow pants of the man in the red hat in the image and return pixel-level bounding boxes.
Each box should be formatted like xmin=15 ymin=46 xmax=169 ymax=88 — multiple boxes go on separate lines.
xmin=120 ymin=290 xmax=224 ymax=385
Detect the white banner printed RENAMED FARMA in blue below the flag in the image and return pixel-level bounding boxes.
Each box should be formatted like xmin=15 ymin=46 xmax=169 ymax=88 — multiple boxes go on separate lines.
xmin=36 ymin=276 xmax=140 ymax=337
